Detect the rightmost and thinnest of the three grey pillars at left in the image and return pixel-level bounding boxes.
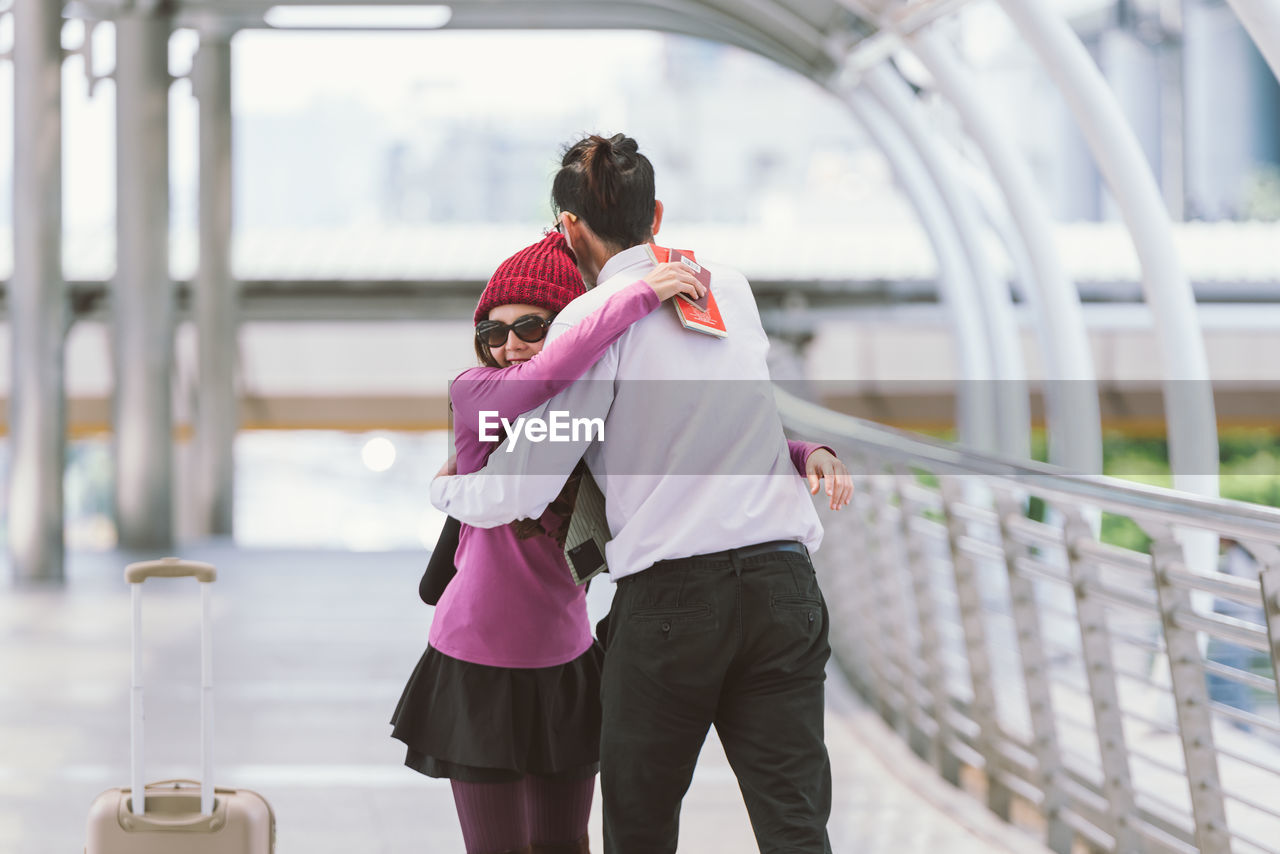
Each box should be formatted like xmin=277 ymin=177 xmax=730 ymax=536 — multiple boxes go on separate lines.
xmin=191 ymin=31 xmax=238 ymax=536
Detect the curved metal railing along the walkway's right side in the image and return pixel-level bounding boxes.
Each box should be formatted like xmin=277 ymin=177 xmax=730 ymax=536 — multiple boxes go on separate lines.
xmin=778 ymin=389 xmax=1280 ymax=854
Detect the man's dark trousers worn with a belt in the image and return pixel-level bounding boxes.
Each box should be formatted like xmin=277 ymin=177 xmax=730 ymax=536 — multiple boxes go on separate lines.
xmin=598 ymin=552 xmax=831 ymax=854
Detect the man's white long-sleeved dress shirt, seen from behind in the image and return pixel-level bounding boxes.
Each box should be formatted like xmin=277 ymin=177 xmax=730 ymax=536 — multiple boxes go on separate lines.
xmin=431 ymin=246 xmax=822 ymax=580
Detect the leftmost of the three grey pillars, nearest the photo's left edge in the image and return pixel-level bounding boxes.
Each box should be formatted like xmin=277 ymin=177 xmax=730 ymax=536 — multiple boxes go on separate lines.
xmin=8 ymin=0 xmax=69 ymax=581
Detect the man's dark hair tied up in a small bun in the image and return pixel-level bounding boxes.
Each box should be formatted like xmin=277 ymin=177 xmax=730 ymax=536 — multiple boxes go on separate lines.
xmin=552 ymin=133 xmax=654 ymax=251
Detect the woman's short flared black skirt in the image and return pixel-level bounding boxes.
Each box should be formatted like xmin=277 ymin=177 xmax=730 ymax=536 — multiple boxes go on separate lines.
xmin=392 ymin=644 xmax=604 ymax=782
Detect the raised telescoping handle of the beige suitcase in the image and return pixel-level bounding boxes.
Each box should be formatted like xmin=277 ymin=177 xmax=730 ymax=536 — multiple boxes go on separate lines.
xmin=124 ymin=557 xmax=218 ymax=816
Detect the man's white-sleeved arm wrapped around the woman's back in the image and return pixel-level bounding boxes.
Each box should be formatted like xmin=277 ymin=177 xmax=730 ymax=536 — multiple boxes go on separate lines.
xmin=431 ymin=343 xmax=618 ymax=528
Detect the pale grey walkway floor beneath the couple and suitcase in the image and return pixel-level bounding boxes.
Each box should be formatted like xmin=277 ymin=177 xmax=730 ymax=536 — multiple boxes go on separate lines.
xmin=0 ymin=545 xmax=1043 ymax=854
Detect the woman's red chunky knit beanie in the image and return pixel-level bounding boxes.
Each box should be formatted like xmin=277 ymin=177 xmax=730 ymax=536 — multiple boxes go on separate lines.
xmin=475 ymin=232 xmax=586 ymax=323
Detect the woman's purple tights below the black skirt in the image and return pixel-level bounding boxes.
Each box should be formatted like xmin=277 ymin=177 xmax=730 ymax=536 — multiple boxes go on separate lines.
xmin=449 ymin=775 xmax=595 ymax=854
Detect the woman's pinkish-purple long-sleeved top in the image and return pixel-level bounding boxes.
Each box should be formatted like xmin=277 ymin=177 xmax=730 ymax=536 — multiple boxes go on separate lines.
xmin=429 ymin=280 xmax=823 ymax=668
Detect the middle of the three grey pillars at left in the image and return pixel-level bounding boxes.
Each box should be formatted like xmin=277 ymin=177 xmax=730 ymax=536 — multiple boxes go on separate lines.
xmin=111 ymin=10 xmax=174 ymax=549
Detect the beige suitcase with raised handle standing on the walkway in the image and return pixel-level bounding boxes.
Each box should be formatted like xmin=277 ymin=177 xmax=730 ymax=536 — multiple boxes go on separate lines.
xmin=84 ymin=557 xmax=275 ymax=854
